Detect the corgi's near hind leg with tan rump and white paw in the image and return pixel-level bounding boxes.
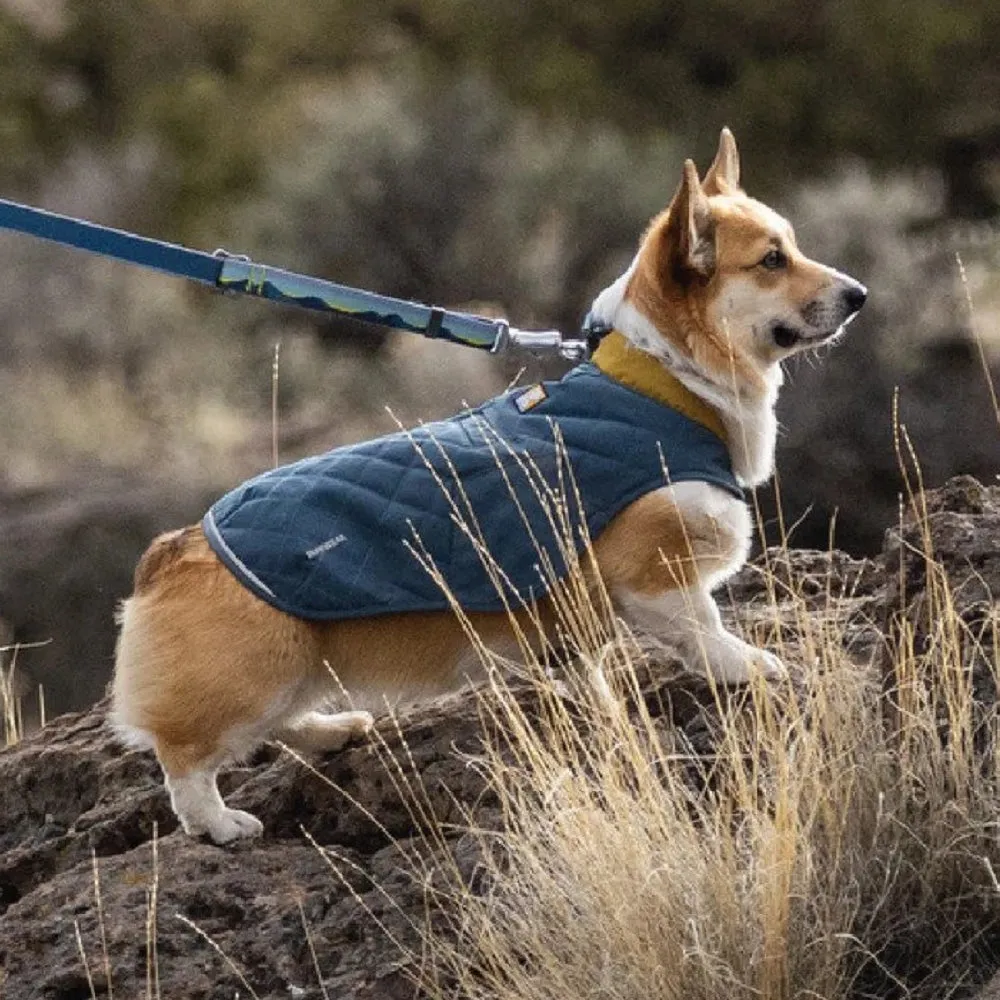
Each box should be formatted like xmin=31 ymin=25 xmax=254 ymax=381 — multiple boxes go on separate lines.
xmin=112 ymin=529 xmax=346 ymax=843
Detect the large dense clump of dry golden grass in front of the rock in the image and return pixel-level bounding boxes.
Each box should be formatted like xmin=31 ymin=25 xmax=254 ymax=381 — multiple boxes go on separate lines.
xmin=404 ymin=524 xmax=1000 ymax=1000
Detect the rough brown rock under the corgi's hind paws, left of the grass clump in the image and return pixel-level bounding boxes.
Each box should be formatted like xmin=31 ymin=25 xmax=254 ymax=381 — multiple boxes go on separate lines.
xmin=0 ymin=701 xmax=488 ymax=1000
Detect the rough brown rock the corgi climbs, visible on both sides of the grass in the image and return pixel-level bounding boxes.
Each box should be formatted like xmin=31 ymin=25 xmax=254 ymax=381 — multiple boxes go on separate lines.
xmin=0 ymin=479 xmax=1000 ymax=1000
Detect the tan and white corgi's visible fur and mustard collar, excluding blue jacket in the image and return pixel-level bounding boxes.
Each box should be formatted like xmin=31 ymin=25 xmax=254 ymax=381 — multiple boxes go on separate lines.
xmin=113 ymin=129 xmax=866 ymax=843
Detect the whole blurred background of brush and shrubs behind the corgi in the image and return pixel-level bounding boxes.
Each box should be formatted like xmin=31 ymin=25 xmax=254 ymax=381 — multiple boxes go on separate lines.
xmin=0 ymin=0 xmax=1000 ymax=707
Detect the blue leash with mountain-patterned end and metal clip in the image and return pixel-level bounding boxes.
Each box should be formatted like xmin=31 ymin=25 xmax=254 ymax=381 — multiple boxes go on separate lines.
xmin=0 ymin=198 xmax=587 ymax=361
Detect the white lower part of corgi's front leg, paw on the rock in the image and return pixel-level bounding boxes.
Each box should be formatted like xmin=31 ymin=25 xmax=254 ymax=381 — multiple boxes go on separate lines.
xmin=620 ymin=587 xmax=786 ymax=684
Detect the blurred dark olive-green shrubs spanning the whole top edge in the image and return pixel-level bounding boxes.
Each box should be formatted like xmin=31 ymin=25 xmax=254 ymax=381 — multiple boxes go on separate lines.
xmin=0 ymin=0 xmax=1000 ymax=228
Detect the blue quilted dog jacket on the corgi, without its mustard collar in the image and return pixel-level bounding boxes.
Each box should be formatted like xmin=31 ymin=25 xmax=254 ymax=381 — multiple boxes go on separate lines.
xmin=203 ymin=363 xmax=742 ymax=620
